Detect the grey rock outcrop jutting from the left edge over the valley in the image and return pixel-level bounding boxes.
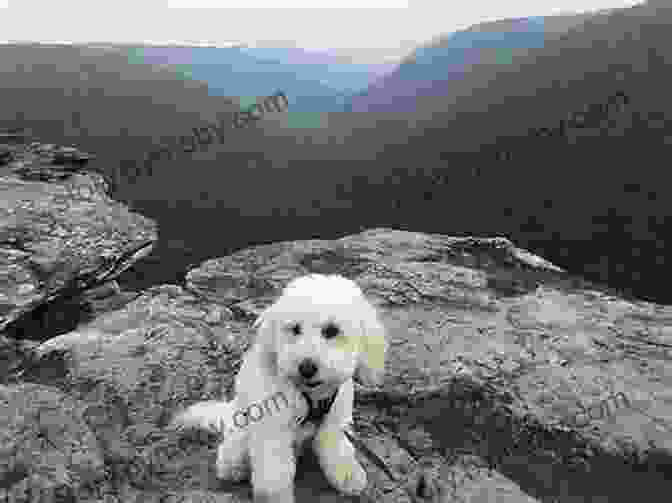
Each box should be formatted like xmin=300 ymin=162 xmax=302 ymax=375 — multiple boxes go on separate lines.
xmin=0 ymin=139 xmax=157 ymax=382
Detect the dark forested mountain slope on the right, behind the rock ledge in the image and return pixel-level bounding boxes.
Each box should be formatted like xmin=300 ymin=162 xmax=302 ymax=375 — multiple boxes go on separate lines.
xmin=323 ymin=1 xmax=672 ymax=303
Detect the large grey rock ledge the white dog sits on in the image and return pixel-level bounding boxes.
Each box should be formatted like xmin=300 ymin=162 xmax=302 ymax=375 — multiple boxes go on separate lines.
xmin=0 ymin=224 xmax=672 ymax=503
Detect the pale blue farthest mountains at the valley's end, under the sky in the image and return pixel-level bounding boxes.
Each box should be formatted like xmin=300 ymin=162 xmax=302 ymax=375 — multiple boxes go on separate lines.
xmin=95 ymin=45 xmax=396 ymax=113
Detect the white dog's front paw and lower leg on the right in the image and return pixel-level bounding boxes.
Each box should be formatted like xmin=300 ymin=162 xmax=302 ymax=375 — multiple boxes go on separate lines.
xmin=313 ymin=424 xmax=367 ymax=496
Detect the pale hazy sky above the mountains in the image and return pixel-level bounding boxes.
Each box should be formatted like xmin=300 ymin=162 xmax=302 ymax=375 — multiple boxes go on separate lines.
xmin=0 ymin=0 xmax=643 ymax=59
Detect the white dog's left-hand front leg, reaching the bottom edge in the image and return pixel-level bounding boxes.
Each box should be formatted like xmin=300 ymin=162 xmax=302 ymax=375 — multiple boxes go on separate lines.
xmin=249 ymin=431 xmax=296 ymax=503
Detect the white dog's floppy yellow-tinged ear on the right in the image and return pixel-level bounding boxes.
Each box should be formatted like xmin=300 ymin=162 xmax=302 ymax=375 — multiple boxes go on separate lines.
xmin=356 ymin=302 xmax=387 ymax=386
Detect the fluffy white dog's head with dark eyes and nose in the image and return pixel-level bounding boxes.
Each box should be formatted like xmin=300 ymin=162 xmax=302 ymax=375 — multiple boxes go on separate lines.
xmin=254 ymin=274 xmax=387 ymax=392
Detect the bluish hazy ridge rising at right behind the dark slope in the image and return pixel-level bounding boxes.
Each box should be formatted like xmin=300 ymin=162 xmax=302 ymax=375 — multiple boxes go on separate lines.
xmin=346 ymin=14 xmax=592 ymax=112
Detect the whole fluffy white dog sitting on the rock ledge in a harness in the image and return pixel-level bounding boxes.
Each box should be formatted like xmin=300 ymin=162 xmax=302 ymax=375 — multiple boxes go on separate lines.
xmin=174 ymin=274 xmax=387 ymax=503
